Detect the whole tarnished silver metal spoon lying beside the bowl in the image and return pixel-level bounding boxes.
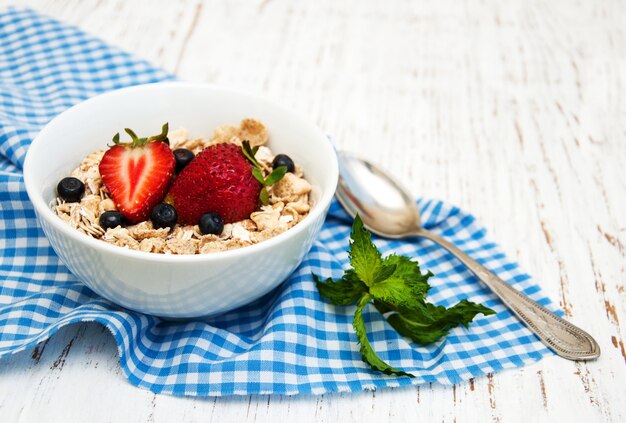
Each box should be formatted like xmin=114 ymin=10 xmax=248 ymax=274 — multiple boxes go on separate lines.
xmin=336 ymin=152 xmax=600 ymax=360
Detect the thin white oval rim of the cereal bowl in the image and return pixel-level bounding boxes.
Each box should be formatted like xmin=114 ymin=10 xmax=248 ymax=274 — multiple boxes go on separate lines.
xmin=23 ymin=81 xmax=339 ymax=264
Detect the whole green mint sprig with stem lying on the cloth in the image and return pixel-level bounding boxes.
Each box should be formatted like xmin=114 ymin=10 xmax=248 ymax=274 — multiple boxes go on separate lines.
xmin=313 ymin=215 xmax=495 ymax=377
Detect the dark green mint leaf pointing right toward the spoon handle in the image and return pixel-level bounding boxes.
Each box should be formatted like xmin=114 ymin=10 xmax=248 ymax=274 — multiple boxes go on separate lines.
xmin=387 ymin=300 xmax=495 ymax=344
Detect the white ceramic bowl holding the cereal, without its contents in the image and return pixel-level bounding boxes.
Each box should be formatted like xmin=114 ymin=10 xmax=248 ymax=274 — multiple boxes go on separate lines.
xmin=24 ymin=82 xmax=337 ymax=318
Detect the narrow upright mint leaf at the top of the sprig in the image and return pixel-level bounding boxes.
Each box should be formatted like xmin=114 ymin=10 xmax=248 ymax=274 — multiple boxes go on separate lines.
xmin=348 ymin=215 xmax=382 ymax=286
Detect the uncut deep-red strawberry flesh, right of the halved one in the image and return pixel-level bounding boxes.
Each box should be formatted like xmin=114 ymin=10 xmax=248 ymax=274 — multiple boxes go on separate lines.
xmin=166 ymin=144 xmax=262 ymax=225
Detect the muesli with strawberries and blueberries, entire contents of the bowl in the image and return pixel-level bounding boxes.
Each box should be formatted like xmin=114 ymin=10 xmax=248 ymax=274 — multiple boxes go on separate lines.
xmin=53 ymin=119 xmax=311 ymax=254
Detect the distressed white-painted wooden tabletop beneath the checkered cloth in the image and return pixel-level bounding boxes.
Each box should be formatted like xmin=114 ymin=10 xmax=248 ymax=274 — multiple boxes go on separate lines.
xmin=0 ymin=0 xmax=626 ymax=422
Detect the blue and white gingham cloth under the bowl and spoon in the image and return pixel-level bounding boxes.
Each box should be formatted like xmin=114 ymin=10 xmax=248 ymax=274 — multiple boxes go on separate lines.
xmin=0 ymin=9 xmax=553 ymax=396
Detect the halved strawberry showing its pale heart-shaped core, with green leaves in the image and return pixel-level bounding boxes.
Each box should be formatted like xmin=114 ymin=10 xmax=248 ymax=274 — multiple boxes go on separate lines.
xmin=98 ymin=123 xmax=176 ymax=223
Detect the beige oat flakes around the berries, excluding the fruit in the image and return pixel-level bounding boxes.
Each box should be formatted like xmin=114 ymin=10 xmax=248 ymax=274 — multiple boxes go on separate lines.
xmin=53 ymin=119 xmax=311 ymax=254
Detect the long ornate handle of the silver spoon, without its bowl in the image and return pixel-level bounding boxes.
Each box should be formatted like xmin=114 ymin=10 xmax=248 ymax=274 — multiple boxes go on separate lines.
xmin=415 ymin=229 xmax=600 ymax=360
